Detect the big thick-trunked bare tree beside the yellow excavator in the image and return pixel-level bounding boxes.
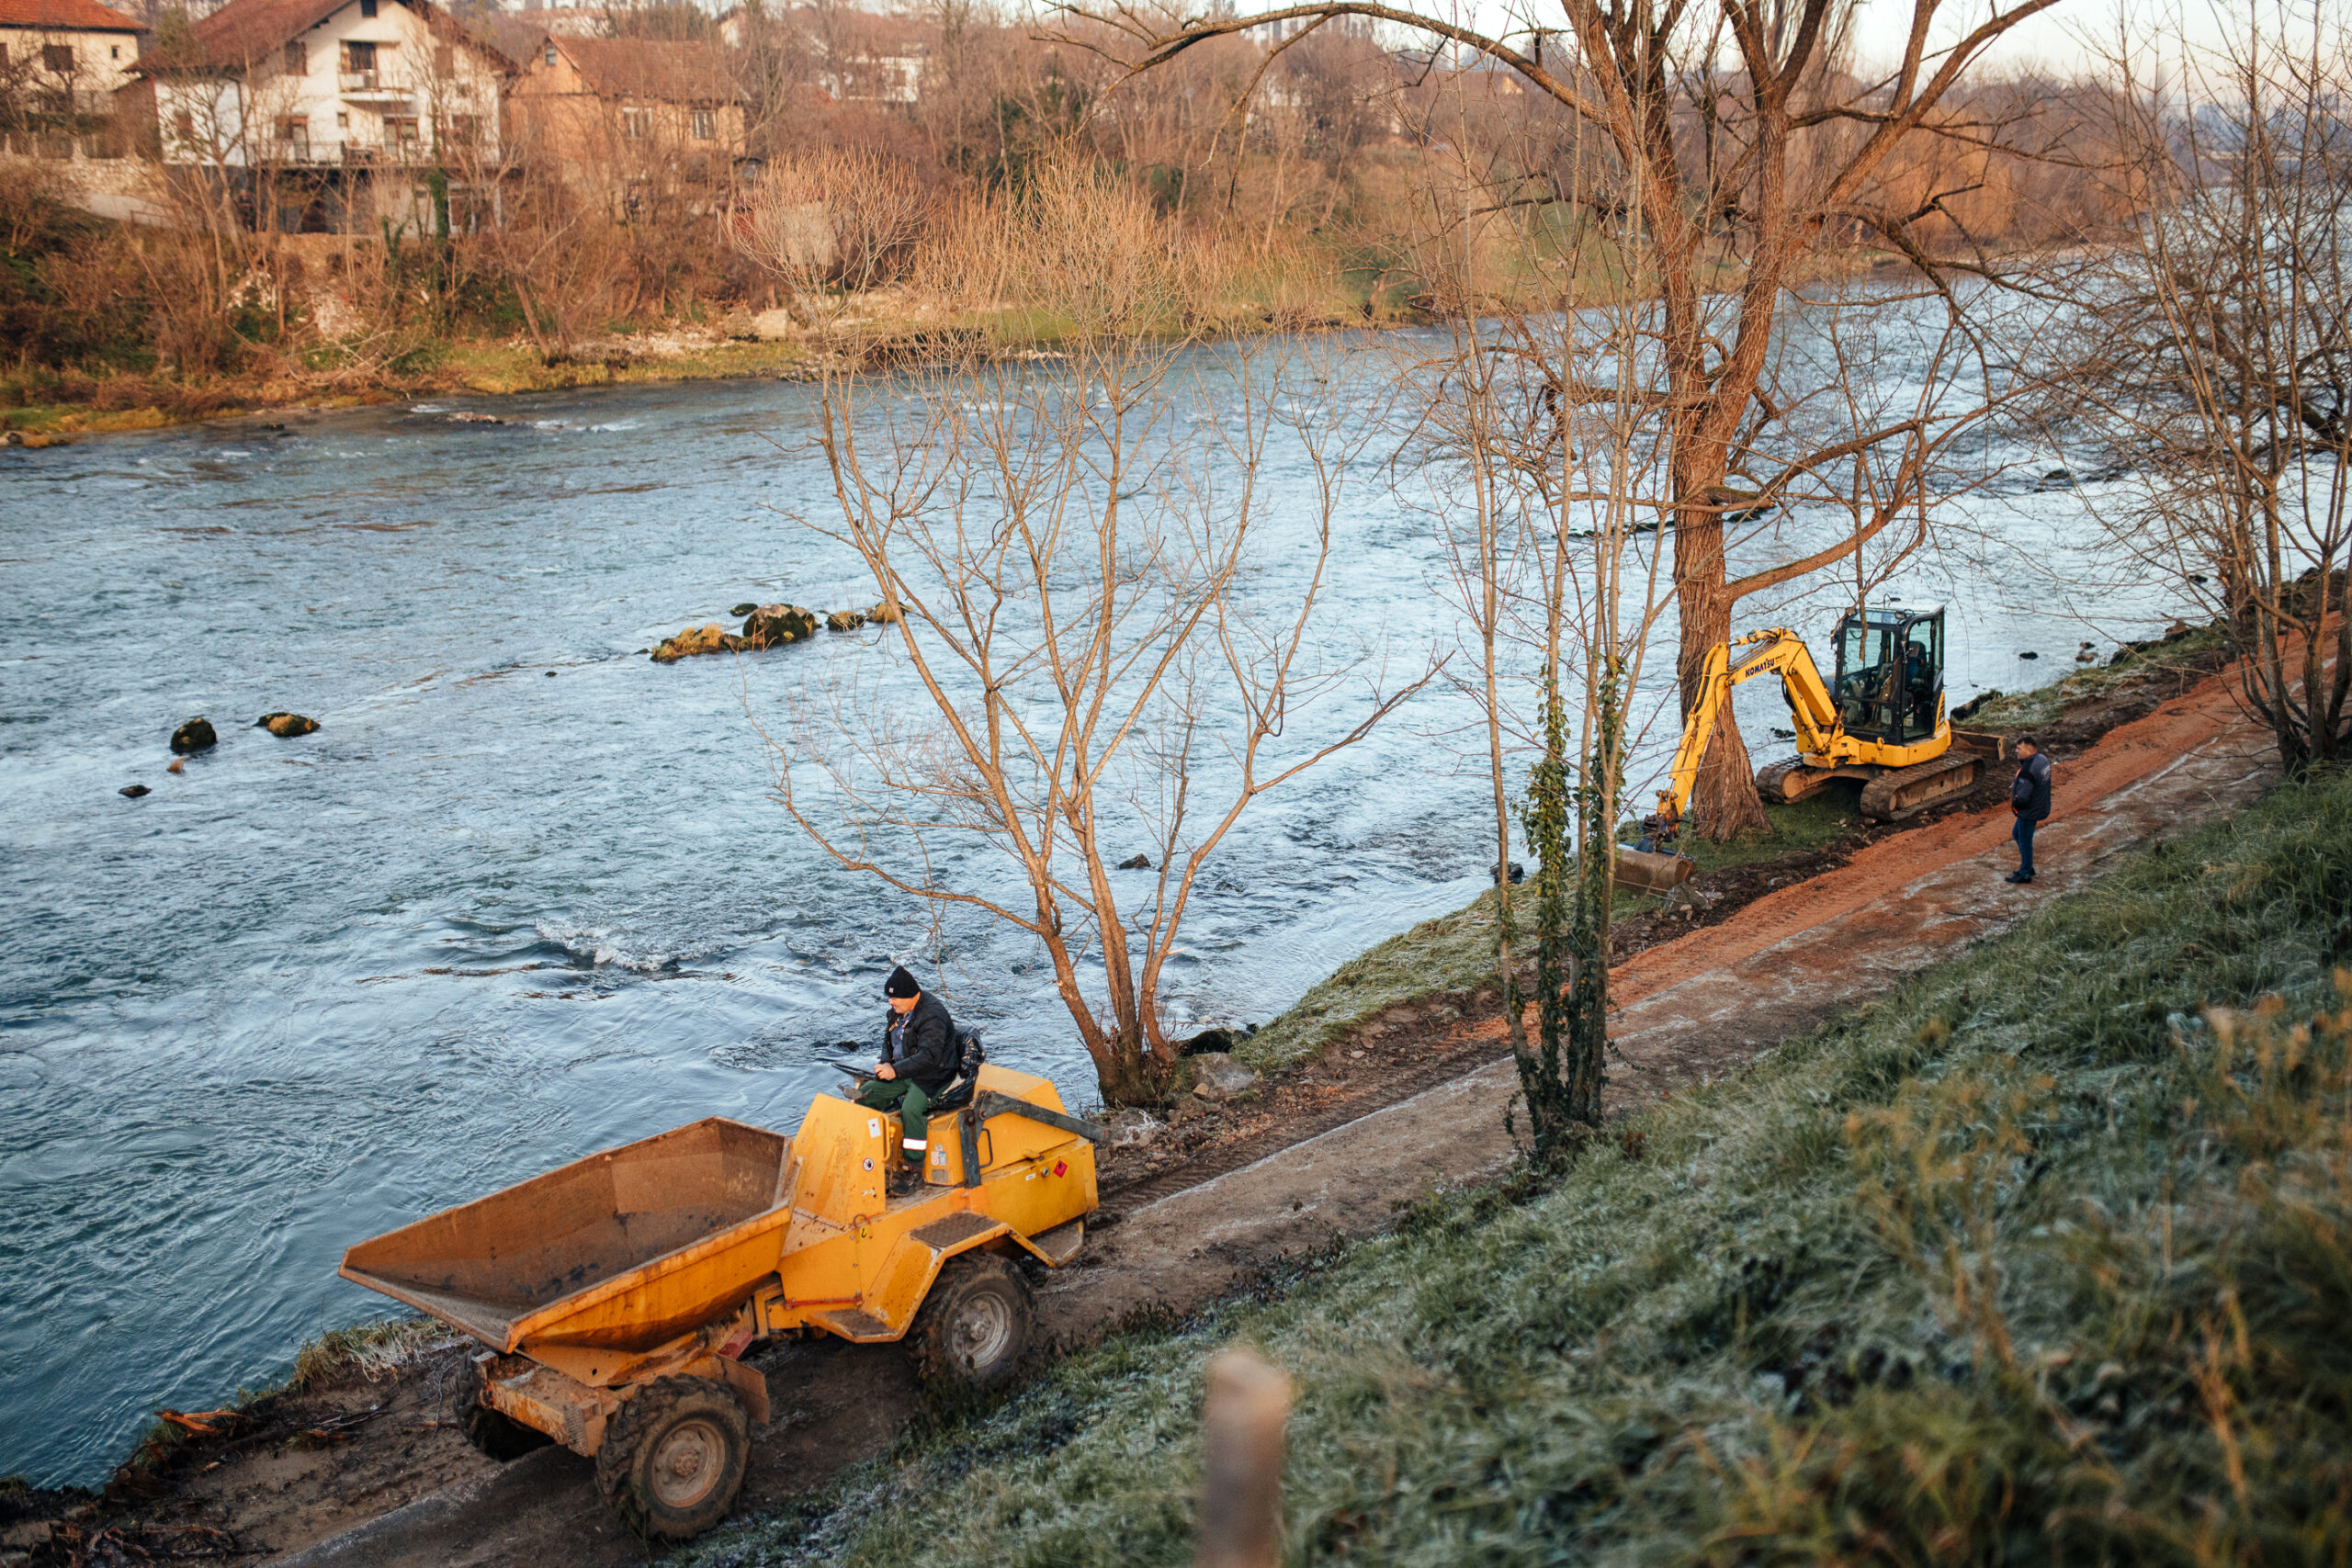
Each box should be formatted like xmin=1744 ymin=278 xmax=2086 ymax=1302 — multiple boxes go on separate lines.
xmin=1061 ymin=0 xmax=2055 ymax=837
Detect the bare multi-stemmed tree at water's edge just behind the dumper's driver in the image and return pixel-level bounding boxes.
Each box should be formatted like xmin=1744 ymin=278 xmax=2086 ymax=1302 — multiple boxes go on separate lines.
xmin=752 ymin=167 xmax=1428 ymax=1100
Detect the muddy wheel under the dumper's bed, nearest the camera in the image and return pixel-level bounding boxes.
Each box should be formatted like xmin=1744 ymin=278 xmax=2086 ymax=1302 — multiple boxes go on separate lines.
xmin=595 ymin=1378 xmax=751 ymax=1540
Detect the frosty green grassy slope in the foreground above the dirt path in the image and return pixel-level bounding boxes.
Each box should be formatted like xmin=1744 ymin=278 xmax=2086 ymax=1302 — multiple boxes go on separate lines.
xmin=694 ymin=757 xmax=2352 ymax=1568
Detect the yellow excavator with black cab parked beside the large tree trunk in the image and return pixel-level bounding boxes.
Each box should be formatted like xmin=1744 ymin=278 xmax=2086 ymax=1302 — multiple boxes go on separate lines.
xmin=1616 ymin=606 xmax=1985 ymax=891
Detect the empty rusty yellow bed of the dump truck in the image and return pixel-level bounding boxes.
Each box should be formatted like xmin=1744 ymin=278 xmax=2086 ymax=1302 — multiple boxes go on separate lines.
xmin=341 ymin=1117 xmax=793 ymax=1352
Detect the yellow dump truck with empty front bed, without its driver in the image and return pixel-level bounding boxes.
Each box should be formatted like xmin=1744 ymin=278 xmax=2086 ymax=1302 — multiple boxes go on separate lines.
xmin=341 ymin=1065 xmax=1103 ymax=1540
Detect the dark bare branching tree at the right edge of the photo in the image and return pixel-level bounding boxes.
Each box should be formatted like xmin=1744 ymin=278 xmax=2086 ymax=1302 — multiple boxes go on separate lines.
xmin=2037 ymin=7 xmax=2352 ymax=771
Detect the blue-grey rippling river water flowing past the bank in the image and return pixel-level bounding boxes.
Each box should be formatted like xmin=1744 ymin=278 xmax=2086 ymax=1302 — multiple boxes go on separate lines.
xmin=0 ymin=333 xmax=2178 ymax=1483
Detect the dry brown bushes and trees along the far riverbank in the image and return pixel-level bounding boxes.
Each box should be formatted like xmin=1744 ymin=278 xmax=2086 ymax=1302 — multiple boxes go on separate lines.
xmin=0 ymin=0 xmax=2154 ymax=430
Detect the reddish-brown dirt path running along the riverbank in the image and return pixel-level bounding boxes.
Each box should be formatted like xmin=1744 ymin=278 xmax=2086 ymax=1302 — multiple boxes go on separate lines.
xmin=14 ymin=677 xmax=2275 ymax=1568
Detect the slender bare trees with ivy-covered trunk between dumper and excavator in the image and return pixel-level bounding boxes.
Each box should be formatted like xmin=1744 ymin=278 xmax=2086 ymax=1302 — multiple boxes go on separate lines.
xmin=1411 ymin=95 xmax=1668 ymax=1161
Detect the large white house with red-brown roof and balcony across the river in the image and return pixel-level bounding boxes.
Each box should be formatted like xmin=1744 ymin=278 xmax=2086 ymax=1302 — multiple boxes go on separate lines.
xmin=146 ymin=0 xmax=513 ymax=232
